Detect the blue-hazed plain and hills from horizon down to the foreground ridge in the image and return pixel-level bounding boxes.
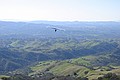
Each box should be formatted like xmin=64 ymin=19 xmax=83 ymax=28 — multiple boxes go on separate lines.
xmin=0 ymin=21 xmax=120 ymax=73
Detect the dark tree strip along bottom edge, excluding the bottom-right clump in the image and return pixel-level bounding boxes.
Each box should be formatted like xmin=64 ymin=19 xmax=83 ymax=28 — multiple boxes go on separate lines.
xmin=1 ymin=73 xmax=88 ymax=80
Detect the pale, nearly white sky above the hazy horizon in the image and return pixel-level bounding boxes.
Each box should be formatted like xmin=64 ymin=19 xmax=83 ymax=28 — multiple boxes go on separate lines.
xmin=0 ymin=0 xmax=120 ymax=21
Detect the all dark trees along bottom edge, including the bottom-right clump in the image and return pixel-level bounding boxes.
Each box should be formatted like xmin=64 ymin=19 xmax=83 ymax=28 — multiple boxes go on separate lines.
xmin=1 ymin=73 xmax=120 ymax=80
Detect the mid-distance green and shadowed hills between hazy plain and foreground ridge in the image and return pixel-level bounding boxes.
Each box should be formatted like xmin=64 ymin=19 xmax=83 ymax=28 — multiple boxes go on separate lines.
xmin=0 ymin=38 xmax=120 ymax=73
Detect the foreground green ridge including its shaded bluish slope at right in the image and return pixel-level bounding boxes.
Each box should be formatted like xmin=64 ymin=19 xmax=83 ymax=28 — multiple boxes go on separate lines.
xmin=29 ymin=52 xmax=120 ymax=80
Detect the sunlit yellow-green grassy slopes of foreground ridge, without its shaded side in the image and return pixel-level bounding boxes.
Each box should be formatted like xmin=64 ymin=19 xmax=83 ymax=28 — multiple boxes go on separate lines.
xmin=31 ymin=56 xmax=120 ymax=80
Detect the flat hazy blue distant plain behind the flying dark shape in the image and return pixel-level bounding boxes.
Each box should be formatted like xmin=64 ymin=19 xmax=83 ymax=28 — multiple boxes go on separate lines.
xmin=0 ymin=21 xmax=120 ymax=39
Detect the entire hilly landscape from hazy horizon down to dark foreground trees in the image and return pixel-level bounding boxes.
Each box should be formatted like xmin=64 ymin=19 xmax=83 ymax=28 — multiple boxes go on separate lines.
xmin=0 ymin=21 xmax=120 ymax=79
